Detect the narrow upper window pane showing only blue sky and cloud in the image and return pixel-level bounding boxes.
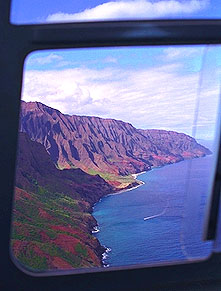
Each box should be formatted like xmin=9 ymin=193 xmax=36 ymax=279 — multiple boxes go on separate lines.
xmin=11 ymin=0 xmax=221 ymax=24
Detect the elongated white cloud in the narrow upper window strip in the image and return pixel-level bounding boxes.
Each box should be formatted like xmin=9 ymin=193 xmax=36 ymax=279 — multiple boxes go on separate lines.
xmin=46 ymin=0 xmax=209 ymax=22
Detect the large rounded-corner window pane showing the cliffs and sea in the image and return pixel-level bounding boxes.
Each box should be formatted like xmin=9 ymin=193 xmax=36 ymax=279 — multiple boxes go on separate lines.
xmin=11 ymin=46 xmax=221 ymax=273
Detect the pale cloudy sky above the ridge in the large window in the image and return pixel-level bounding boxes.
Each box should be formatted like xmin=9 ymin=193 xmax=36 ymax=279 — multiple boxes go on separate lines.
xmin=22 ymin=46 xmax=221 ymax=139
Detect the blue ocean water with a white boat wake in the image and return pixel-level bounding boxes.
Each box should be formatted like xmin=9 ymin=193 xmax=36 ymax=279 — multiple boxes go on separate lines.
xmin=93 ymin=155 xmax=213 ymax=266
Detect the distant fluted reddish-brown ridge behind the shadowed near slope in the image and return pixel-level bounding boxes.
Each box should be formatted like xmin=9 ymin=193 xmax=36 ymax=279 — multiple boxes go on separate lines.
xmin=20 ymin=101 xmax=210 ymax=188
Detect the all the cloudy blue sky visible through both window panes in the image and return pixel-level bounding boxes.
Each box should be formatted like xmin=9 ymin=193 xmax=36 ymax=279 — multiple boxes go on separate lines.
xmin=11 ymin=0 xmax=221 ymax=139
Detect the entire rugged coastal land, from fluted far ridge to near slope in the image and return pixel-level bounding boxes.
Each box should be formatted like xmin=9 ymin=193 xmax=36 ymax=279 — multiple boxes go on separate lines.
xmin=11 ymin=101 xmax=211 ymax=271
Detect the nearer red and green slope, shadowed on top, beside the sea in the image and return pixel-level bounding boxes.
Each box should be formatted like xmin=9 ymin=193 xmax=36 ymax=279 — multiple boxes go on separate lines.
xmin=11 ymin=133 xmax=113 ymax=272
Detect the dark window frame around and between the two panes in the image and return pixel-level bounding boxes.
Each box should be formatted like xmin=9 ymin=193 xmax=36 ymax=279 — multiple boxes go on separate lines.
xmin=0 ymin=0 xmax=221 ymax=290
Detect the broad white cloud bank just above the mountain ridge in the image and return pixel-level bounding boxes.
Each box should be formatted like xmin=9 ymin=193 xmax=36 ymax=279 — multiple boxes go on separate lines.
xmin=22 ymin=56 xmax=219 ymax=140
